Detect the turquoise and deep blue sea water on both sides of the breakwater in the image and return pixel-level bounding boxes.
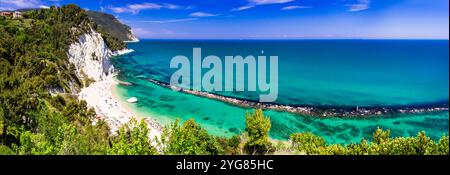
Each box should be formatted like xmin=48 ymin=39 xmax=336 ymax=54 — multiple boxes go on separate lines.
xmin=113 ymin=40 xmax=449 ymax=143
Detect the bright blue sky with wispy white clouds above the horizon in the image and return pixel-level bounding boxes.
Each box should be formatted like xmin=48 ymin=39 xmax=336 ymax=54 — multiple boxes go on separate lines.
xmin=0 ymin=0 xmax=449 ymax=39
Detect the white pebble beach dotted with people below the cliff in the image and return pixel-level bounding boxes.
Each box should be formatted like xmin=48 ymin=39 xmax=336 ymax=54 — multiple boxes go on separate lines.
xmin=78 ymin=75 xmax=162 ymax=139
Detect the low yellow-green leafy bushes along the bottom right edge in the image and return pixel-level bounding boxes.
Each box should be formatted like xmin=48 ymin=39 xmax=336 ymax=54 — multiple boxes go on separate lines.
xmin=290 ymin=128 xmax=449 ymax=155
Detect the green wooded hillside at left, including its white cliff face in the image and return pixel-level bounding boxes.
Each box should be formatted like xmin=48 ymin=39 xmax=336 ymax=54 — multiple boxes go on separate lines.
xmin=0 ymin=5 xmax=146 ymax=154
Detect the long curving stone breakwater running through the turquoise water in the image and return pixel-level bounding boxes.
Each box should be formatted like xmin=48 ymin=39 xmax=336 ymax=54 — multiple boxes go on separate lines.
xmin=147 ymin=79 xmax=449 ymax=118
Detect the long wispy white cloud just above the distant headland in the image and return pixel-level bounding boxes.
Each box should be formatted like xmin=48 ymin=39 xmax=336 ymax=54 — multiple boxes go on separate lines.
xmin=107 ymin=2 xmax=182 ymax=14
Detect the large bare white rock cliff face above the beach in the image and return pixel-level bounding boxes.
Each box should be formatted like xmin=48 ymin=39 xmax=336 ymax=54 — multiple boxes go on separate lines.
xmin=67 ymin=30 xmax=114 ymax=81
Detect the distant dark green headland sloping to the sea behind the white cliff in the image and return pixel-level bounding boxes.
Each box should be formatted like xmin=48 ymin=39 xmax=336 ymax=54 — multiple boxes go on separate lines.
xmin=86 ymin=11 xmax=138 ymax=41
